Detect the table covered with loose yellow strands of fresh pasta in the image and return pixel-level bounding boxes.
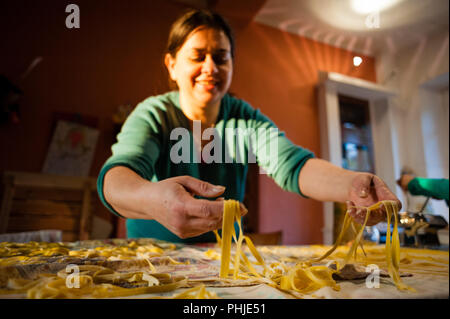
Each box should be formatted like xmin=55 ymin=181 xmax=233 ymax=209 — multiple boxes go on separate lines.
xmin=0 ymin=239 xmax=449 ymax=299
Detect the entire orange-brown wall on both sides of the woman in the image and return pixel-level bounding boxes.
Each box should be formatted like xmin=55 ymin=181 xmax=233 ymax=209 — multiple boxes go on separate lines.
xmin=0 ymin=0 xmax=375 ymax=244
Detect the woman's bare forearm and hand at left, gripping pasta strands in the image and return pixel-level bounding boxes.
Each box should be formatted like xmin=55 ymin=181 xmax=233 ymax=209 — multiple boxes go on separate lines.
xmin=104 ymin=166 xmax=247 ymax=238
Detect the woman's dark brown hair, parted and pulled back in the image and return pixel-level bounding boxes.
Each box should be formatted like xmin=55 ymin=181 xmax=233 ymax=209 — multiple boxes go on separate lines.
xmin=166 ymin=9 xmax=234 ymax=59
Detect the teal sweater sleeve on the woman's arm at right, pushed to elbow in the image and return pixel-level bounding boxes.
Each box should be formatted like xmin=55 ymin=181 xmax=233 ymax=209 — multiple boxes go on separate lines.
xmin=242 ymin=102 xmax=314 ymax=197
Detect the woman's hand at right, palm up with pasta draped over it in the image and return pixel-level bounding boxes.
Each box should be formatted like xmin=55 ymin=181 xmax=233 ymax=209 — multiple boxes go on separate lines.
xmin=347 ymin=173 xmax=402 ymax=226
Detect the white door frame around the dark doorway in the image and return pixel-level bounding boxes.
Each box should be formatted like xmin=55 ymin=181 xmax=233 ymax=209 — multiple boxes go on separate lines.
xmin=317 ymin=71 xmax=403 ymax=245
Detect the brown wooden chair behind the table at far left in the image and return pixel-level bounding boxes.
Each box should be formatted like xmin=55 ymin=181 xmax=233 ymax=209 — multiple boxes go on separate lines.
xmin=0 ymin=172 xmax=96 ymax=241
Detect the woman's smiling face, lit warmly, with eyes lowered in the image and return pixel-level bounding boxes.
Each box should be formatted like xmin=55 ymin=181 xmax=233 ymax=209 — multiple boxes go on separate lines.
xmin=165 ymin=27 xmax=233 ymax=107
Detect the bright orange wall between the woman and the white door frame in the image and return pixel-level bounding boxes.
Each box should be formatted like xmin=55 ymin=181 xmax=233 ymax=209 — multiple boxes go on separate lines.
xmin=232 ymin=23 xmax=376 ymax=244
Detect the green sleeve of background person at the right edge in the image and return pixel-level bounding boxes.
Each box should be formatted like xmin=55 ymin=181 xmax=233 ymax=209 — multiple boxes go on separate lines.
xmin=408 ymin=177 xmax=449 ymax=201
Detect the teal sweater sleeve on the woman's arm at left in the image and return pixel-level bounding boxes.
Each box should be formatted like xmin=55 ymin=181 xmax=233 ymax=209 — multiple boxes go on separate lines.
xmin=97 ymin=102 xmax=160 ymax=217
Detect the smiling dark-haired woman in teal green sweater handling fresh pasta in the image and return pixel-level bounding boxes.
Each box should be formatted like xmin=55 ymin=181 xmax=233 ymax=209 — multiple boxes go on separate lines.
xmin=98 ymin=10 xmax=401 ymax=242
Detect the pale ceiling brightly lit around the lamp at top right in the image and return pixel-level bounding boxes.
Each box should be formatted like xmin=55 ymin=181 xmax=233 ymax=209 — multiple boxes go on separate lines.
xmin=254 ymin=0 xmax=449 ymax=56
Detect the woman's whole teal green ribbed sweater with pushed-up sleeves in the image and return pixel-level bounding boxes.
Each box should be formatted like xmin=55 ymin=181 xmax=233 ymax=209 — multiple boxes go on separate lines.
xmin=97 ymin=91 xmax=314 ymax=243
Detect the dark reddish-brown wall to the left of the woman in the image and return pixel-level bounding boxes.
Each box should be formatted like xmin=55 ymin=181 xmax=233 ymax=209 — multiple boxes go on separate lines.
xmin=0 ymin=0 xmax=184 ymax=226
